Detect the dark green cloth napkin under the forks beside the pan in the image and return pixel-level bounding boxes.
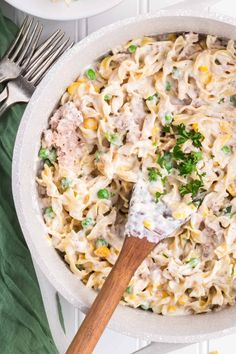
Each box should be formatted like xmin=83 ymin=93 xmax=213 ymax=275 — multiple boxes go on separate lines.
xmin=0 ymin=10 xmax=58 ymax=354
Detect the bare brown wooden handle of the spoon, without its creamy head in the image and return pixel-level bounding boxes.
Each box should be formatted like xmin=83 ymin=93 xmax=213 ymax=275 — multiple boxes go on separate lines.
xmin=66 ymin=237 xmax=155 ymax=354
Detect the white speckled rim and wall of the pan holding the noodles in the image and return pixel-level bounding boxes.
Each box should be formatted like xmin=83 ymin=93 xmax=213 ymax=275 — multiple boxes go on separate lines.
xmin=13 ymin=11 xmax=236 ymax=343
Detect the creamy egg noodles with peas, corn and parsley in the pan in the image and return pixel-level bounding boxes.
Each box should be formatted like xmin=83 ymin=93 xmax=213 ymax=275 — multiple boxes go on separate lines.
xmin=37 ymin=33 xmax=236 ymax=315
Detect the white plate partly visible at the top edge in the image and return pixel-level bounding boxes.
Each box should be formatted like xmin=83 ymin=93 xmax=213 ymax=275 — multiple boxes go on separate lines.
xmin=5 ymin=0 xmax=122 ymax=21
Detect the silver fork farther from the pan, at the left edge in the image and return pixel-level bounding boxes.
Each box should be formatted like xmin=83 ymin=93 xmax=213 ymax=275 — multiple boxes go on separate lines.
xmin=0 ymin=17 xmax=43 ymax=83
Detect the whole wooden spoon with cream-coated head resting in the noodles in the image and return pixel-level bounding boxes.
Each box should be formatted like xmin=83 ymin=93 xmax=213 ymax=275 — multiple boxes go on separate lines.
xmin=66 ymin=180 xmax=192 ymax=354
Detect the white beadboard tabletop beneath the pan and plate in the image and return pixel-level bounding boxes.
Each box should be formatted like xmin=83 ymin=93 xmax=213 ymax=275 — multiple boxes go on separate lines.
xmin=0 ymin=0 xmax=236 ymax=354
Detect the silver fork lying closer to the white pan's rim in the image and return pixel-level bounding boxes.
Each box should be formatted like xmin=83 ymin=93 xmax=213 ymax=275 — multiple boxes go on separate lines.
xmin=0 ymin=34 xmax=74 ymax=117
